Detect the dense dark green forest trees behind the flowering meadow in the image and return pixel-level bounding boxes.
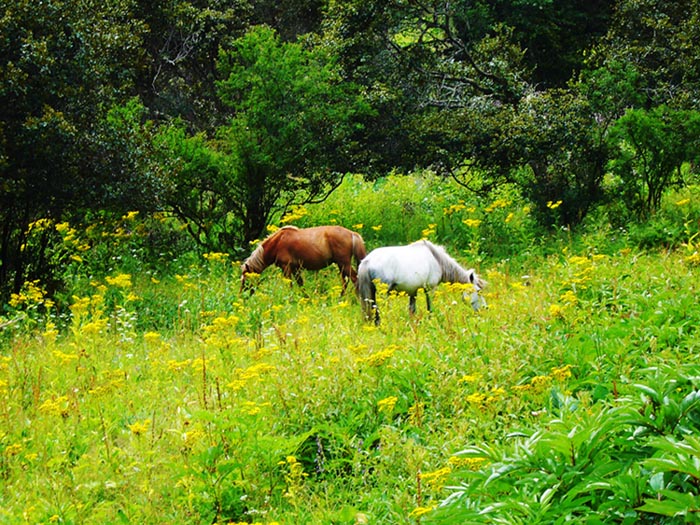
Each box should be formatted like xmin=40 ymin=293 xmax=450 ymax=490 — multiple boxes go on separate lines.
xmin=0 ymin=0 xmax=700 ymax=296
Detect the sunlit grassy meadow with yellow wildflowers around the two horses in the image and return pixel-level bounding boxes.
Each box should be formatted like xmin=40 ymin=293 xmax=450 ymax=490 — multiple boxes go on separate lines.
xmin=0 ymin=177 xmax=700 ymax=525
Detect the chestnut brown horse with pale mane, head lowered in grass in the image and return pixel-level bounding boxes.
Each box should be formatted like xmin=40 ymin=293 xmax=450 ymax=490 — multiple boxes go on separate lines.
xmin=241 ymin=226 xmax=367 ymax=293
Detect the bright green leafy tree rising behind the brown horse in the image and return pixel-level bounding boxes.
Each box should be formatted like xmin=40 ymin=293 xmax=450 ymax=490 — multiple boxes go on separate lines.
xmin=160 ymin=27 xmax=369 ymax=249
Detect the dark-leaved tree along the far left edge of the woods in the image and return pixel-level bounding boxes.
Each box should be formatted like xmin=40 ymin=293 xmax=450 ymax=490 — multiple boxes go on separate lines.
xmin=0 ymin=0 xmax=147 ymax=294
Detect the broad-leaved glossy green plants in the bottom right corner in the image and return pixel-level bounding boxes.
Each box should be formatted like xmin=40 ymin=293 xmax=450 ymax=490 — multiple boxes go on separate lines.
xmin=430 ymin=365 xmax=700 ymax=524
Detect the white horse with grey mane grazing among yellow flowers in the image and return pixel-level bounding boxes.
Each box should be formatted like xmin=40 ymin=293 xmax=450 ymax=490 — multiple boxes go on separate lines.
xmin=357 ymin=240 xmax=486 ymax=325
